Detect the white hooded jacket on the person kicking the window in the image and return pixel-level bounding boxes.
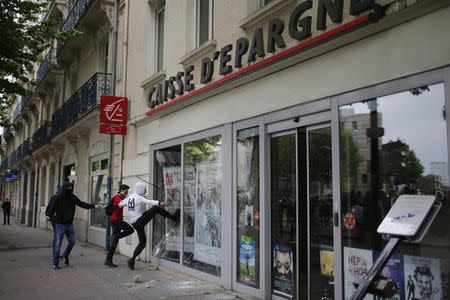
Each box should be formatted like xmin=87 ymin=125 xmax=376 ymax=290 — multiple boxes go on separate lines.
xmin=119 ymin=182 xmax=159 ymax=223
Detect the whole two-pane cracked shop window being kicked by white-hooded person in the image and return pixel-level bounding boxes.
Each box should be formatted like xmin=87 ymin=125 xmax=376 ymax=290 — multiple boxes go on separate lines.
xmin=153 ymin=135 xmax=222 ymax=276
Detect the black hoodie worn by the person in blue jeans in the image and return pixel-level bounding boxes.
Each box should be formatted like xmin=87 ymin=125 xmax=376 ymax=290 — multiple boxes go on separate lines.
xmin=47 ymin=183 xmax=95 ymax=224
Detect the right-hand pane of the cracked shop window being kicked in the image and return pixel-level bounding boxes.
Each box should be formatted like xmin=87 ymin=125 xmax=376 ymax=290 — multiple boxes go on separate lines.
xmin=183 ymin=135 xmax=222 ymax=276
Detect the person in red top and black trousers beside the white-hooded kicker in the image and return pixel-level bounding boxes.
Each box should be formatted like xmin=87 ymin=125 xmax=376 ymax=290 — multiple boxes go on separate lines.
xmin=105 ymin=184 xmax=134 ymax=267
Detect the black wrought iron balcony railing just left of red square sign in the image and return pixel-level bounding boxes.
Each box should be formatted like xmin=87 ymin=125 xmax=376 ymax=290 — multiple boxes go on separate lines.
xmin=51 ymin=73 xmax=111 ymax=138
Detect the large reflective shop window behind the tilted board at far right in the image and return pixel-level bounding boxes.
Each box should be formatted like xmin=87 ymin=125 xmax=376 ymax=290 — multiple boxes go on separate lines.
xmin=339 ymin=84 xmax=450 ymax=299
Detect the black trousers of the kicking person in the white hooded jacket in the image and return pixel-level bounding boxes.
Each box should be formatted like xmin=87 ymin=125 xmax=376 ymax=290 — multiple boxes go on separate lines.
xmin=131 ymin=206 xmax=180 ymax=260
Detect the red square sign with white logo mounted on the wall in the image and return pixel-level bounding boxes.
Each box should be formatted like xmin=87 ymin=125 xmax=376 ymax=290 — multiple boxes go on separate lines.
xmin=100 ymin=95 xmax=128 ymax=124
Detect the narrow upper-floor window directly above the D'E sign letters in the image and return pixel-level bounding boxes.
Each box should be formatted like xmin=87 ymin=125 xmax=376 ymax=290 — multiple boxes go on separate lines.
xmin=195 ymin=0 xmax=213 ymax=47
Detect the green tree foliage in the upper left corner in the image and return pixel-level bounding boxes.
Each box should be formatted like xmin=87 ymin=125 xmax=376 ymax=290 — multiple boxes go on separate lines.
xmin=0 ymin=0 xmax=76 ymax=126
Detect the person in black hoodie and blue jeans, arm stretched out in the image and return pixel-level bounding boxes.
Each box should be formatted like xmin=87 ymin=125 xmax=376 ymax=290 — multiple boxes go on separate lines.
xmin=48 ymin=182 xmax=102 ymax=270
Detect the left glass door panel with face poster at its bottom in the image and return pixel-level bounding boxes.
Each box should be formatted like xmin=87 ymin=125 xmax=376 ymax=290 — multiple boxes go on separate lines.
xmin=270 ymin=131 xmax=298 ymax=299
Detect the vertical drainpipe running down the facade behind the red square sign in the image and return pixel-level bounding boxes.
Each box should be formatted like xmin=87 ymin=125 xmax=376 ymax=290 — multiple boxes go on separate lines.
xmin=105 ymin=0 xmax=120 ymax=250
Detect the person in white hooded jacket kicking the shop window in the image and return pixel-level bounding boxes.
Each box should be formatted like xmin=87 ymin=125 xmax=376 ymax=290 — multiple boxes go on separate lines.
xmin=119 ymin=182 xmax=180 ymax=270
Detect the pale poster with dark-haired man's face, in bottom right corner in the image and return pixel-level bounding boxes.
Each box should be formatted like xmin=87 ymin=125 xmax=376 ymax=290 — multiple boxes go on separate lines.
xmin=403 ymin=255 xmax=444 ymax=300
